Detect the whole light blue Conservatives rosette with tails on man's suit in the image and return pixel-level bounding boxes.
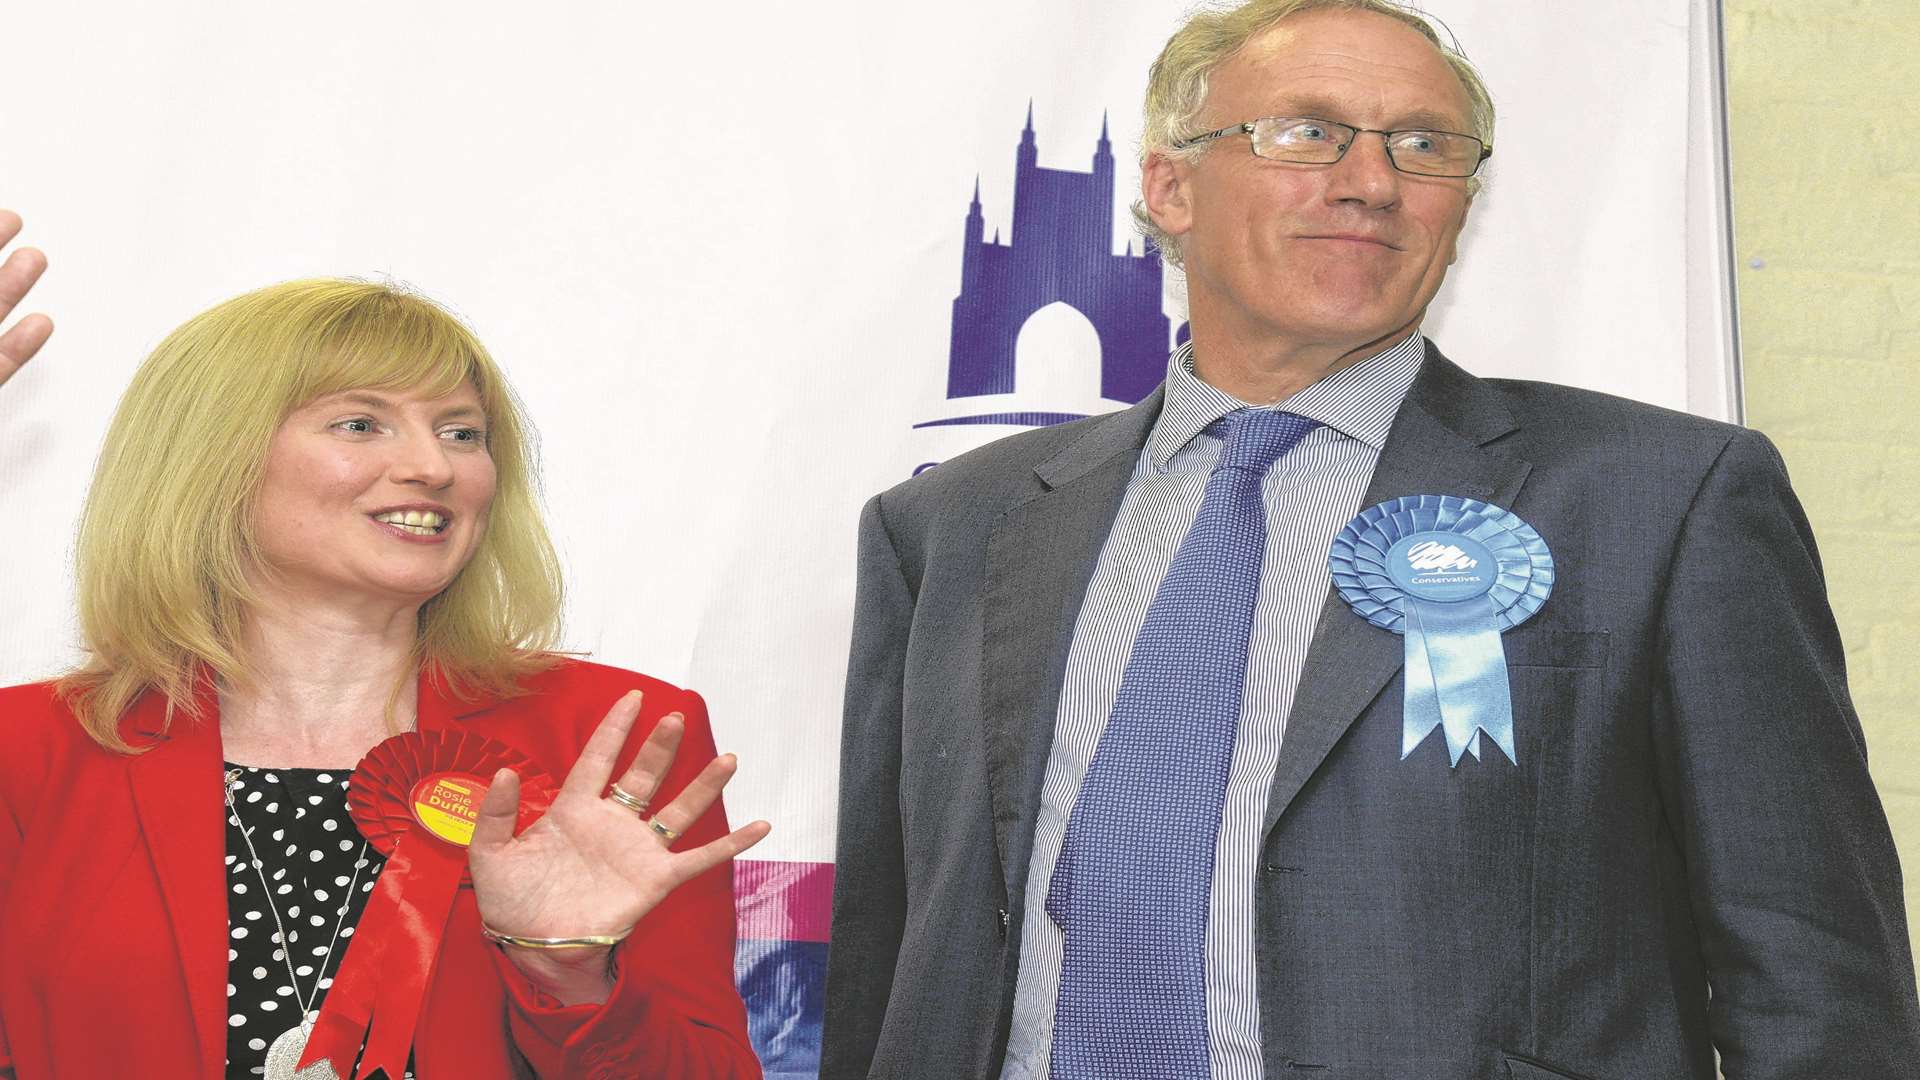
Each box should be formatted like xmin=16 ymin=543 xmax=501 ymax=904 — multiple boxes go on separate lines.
xmin=1329 ymin=496 xmax=1553 ymax=765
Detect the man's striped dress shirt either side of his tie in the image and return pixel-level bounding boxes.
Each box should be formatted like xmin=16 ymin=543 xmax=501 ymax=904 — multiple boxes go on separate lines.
xmin=1000 ymin=332 xmax=1425 ymax=1080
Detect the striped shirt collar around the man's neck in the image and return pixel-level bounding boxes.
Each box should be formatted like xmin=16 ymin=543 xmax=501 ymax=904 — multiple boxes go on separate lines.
xmin=1146 ymin=332 xmax=1427 ymax=469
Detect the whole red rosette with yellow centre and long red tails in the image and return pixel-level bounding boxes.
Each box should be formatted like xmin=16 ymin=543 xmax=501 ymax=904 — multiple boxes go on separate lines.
xmin=296 ymin=730 xmax=557 ymax=1078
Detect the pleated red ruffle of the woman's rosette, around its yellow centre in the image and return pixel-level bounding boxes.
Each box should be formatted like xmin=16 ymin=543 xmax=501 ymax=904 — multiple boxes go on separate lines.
xmin=348 ymin=730 xmax=559 ymax=886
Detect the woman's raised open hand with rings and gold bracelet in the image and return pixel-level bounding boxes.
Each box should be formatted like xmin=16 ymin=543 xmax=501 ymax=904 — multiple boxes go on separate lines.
xmin=467 ymin=690 xmax=772 ymax=1001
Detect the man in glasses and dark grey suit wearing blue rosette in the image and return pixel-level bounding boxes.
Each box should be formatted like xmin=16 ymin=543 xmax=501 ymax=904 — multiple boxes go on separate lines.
xmin=822 ymin=0 xmax=1920 ymax=1080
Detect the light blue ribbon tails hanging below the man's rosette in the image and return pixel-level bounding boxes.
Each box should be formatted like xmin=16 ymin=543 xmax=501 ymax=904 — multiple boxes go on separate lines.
xmin=1407 ymin=596 xmax=1519 ymax=765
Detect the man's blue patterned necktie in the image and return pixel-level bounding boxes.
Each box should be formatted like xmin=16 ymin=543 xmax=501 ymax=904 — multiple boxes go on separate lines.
xmin=1046 ymin=409 xmax=1319 ymax=1080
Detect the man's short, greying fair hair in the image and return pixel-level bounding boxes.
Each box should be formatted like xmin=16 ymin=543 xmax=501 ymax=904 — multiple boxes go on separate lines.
xmin=1133 ymin=0 xmax=1494 ymax=267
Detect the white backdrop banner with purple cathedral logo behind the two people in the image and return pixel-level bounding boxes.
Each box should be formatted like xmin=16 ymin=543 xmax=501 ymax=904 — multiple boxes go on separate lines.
xmin=0 ymin=0 xmax=1738 ymax=1076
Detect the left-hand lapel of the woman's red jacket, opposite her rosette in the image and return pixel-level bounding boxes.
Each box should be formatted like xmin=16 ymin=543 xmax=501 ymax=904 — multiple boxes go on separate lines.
xmin=127 ymin=692 xmax=227 ymax=1074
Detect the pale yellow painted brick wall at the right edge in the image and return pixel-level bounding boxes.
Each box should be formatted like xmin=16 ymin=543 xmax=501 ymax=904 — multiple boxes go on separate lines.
xmin=1726 ymin=0 xmax=1920 ymax=968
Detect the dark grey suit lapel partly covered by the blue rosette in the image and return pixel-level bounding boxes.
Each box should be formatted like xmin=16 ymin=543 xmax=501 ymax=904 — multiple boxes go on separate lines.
xmin=1263 ymin=342 xmax=1530 ymax=832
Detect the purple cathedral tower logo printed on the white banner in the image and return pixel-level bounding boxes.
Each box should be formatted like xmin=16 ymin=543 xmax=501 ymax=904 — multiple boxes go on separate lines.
xmin=914 ymin=104 xmax=1187 ymax=429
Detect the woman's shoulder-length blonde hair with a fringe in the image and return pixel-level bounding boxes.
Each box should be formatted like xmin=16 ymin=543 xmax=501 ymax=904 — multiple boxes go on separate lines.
xmin=58 ymin=279 xmax=561 ymax=753
